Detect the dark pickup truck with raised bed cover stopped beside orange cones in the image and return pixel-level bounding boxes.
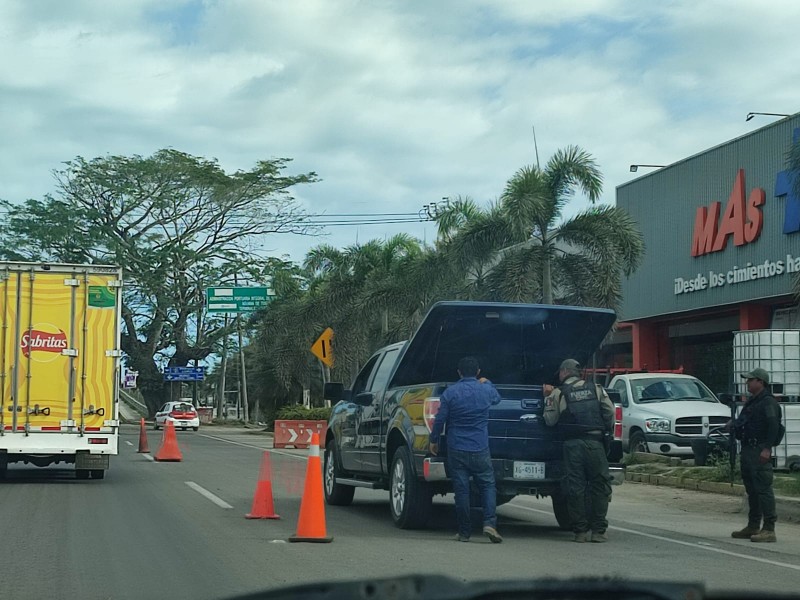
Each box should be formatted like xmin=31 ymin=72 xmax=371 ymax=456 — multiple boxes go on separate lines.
xmin=324 ymin=302 xmax=624 ymax=529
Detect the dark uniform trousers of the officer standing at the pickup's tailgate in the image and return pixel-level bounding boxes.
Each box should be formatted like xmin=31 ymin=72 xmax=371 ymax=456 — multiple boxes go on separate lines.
xmin=564 ymin=439 xmax=611 ymax=533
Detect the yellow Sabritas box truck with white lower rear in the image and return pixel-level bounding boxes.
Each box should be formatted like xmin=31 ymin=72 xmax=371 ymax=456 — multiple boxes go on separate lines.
xmin=0 ymin=262 xmax=122 ymax=479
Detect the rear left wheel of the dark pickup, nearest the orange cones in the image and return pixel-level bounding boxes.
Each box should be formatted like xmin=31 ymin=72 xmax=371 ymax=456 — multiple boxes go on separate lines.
xmin=389 ymin=446 xmax=433 ymax=529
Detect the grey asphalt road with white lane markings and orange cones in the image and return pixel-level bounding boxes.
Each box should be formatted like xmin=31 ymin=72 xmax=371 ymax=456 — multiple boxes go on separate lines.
xmin=0 ymin=427 xmax=800 ymax=600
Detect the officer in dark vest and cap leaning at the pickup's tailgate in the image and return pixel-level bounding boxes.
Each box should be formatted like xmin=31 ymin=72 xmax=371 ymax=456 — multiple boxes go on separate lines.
xmin=544 ymin=358 xmax=614 ymax=543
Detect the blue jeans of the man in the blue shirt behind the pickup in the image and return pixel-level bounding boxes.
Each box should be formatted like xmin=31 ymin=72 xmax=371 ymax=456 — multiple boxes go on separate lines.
xmin=447 ymin=448 xmax=497 ymax=537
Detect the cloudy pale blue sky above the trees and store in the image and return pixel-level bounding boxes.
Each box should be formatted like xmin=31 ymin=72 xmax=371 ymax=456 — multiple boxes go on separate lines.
xmin=0 ymin=0 xmax=800 ymax=259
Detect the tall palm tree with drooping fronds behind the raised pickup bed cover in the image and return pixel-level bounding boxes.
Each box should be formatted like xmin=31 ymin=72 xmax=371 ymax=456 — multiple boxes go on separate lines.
xmin=438 ymin=146 xmax=644 ymax=307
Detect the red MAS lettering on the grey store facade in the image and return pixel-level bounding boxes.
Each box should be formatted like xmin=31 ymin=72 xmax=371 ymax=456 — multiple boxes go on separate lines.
xmin=692 ymin=169 xmax=766 ymax=256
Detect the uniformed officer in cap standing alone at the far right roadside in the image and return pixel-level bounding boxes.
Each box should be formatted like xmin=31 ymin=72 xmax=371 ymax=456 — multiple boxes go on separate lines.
xmin=731 ymin=369 xmax=781 ymax=542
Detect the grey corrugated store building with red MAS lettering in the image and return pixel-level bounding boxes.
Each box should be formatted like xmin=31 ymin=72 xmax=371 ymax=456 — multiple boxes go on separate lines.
xmin=614 ymin=113 xmax=800 ymax=391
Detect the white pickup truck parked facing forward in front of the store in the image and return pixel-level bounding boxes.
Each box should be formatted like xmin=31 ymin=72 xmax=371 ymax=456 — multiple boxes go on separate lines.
xmin=609 ymin=373 xmax=730 ymax=456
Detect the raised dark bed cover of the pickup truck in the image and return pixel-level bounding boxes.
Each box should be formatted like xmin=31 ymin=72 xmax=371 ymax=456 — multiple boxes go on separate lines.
xmin=391 ymin=302 xmax=616 ymax=386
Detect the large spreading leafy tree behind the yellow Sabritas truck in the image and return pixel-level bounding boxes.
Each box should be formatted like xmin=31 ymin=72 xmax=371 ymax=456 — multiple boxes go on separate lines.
xmin=0 ymin=149 xmax=317 ymax=413
